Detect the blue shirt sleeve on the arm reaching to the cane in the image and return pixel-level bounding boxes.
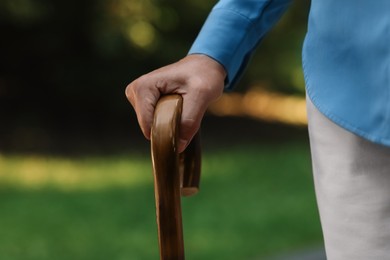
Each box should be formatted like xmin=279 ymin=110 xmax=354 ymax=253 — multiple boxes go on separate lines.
xmin=189 ymin=0 xmax=292 ymax=89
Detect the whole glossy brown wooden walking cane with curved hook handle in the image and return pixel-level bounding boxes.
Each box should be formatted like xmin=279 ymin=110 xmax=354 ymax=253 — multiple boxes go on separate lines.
xmin=151 ymin=95 xmax=201 ymax=260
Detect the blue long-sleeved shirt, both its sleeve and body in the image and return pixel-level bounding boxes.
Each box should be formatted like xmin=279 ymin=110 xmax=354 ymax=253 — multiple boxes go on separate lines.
xmin=189 ymin=0 xmax=390 ymax=146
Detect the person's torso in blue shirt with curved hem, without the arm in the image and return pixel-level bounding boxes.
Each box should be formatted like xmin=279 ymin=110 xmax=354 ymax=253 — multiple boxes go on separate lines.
xmin=303 ymin=0 xmax=390 ymax=145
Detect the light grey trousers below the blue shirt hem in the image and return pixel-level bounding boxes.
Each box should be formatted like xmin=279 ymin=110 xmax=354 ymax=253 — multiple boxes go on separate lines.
xmin=307 ymin=98 xmax=390 ymax=260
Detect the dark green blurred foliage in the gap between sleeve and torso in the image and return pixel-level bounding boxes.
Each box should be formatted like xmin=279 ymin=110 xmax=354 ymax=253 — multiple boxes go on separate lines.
xmin=250 ymin=1 xmax=310 ymax=95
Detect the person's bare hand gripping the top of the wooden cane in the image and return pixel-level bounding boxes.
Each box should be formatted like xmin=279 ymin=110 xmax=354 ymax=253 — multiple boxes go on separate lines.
xmin=126 ymin=54 xmax=226 ymax=152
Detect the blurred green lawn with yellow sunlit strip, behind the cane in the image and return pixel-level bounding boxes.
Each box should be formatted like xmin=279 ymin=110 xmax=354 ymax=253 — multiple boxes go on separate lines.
xmin=0 ymin=143 xmax=321 ymax=260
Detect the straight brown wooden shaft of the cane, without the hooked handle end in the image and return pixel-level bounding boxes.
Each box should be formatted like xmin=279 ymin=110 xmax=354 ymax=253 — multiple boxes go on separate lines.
xmin=151 ymin=96 xmax=184 ymax=260
